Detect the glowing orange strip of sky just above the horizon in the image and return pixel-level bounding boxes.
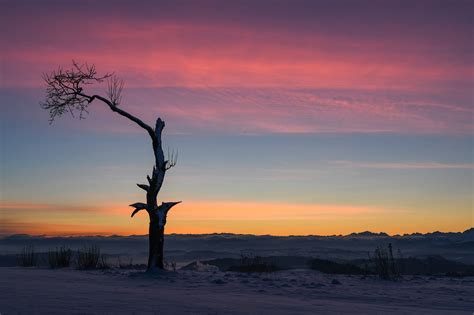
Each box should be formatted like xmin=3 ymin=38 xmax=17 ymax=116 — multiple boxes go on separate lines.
xmin=0 ymin=200 xmax=473 ymax=236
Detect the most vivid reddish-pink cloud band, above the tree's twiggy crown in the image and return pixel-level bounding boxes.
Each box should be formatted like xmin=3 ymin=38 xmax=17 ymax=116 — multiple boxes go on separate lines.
xmin=0 ymin=12 xmax=473 ymax=90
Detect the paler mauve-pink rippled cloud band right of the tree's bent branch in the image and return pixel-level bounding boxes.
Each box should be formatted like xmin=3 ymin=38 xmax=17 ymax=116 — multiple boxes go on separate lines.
xmin=104 ymin=88 xmax=474 ymax=134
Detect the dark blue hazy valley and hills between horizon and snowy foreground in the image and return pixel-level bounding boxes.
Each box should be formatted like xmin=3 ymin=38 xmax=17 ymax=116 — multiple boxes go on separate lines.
xmin=0 ymin=228 xmax=474 ymax=266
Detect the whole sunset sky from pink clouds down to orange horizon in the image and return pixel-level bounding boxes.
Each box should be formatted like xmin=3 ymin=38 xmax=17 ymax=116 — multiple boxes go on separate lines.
xmin=0 ymin=0 xmax=474 ymax=235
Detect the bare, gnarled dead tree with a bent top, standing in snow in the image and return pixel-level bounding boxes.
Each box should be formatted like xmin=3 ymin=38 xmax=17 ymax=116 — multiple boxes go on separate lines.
xmin=41 ymin=61 xmax=181 ymax=270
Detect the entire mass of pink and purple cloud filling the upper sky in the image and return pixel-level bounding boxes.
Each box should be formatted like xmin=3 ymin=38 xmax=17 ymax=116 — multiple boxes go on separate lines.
xmin=0 ymin=1 xmax=474 ymax=134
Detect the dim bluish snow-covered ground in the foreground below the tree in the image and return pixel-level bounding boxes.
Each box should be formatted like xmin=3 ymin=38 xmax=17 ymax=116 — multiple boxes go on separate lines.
xmin=0 ymin=267 xmax=474 ymax=315
